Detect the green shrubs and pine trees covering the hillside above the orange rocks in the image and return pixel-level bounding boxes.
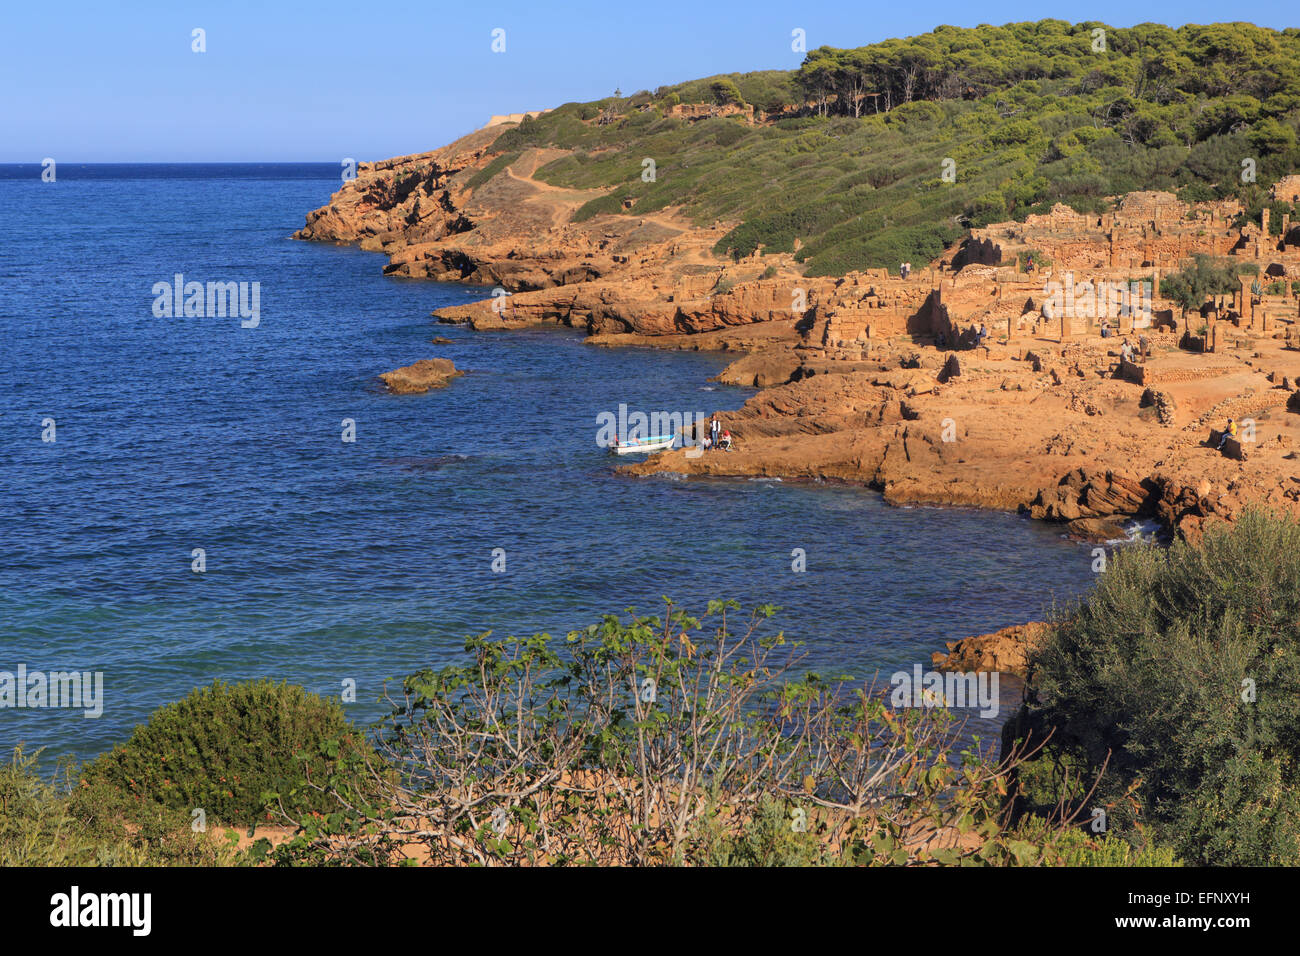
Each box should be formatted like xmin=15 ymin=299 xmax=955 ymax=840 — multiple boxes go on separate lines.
xmin=485 ymin=20 xmax=1300 ymax=276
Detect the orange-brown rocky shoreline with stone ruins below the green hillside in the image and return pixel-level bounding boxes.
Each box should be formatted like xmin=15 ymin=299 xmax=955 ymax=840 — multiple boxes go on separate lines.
xmin=296 ymin=117 xmax=1300 ymax=540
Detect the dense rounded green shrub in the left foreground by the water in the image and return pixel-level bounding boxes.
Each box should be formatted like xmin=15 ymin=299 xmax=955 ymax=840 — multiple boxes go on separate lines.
xmin=83 ymin=680 xmax=367 ymax=825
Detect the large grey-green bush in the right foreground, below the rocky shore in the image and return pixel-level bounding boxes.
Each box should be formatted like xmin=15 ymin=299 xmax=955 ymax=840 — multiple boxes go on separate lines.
xmin=1022 ymin=510 xmax=1300 ymax=865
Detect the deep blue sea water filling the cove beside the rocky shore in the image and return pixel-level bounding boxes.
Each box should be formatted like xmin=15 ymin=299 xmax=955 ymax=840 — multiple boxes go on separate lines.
xmin=0 ymin=164 xmax=1092 ymax=758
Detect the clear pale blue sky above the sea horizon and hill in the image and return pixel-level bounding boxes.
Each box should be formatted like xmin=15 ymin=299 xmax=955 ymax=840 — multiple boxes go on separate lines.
xmin=0 ymin=0 xmax=1300 ymax=163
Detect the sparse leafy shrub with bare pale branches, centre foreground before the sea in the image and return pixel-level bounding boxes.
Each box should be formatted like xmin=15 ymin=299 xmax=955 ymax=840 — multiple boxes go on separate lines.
xmin=263 ymin=601 xmax=1118 ymax=865
